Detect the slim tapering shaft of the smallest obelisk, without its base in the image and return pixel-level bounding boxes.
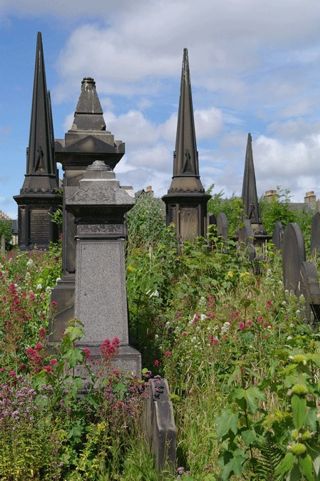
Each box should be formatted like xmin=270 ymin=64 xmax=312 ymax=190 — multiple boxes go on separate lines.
xmin=242 ymin=134 xmax=261 ymax=224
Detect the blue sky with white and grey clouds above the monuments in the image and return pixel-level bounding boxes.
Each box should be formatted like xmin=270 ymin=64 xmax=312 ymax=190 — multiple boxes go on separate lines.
xmin=0 ymin=0 xmax=320 ymax=218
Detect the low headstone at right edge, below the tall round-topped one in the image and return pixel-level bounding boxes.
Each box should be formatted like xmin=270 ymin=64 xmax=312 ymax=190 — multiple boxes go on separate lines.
xmin=300 ymin=262 xmax=320 ymax=322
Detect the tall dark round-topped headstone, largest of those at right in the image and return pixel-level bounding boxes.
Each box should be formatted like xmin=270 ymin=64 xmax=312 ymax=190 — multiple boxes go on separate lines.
xmin=282 ymin=222 xmax=306 ymax=295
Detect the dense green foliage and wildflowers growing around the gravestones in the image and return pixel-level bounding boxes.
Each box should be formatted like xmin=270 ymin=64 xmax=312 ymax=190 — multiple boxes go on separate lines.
xmin=0 ymin=194 xmax=320 ymax=481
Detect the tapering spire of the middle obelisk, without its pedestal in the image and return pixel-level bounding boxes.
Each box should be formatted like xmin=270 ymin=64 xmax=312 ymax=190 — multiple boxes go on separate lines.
xmin=168 ymin=48 xmax=204 ymax=193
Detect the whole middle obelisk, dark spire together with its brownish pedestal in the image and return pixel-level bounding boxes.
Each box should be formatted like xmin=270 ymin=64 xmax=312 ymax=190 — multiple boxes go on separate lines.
xmin=163 ymin=48 xmax=210 ymax=242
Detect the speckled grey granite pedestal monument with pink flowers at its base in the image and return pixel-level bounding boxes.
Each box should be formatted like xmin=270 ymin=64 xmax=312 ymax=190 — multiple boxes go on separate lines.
xmin=58 ymin=161 xmax=141 ymax=375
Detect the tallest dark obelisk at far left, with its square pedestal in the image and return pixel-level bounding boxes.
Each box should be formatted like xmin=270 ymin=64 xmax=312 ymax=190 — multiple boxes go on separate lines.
xmin=14 ymin=32 xmax=62 ymax=249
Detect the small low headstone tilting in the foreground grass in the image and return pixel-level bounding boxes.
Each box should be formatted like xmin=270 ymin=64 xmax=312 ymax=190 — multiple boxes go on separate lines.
xmin=142 ymin=377 xmax=177 ymax=471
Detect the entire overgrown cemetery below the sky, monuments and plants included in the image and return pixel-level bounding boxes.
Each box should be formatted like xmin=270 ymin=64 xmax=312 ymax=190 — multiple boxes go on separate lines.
xmin=0 ymin=33 xmax=320 ymax=481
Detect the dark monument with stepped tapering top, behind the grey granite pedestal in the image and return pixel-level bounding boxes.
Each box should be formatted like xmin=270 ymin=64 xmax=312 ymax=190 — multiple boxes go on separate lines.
xmin=51 ymin=77 xmax=125 ymax=341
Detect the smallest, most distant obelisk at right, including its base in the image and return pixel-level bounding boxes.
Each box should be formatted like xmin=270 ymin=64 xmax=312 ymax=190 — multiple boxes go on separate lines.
xmin=242 ymin=133 xmax=269 ymax=243
